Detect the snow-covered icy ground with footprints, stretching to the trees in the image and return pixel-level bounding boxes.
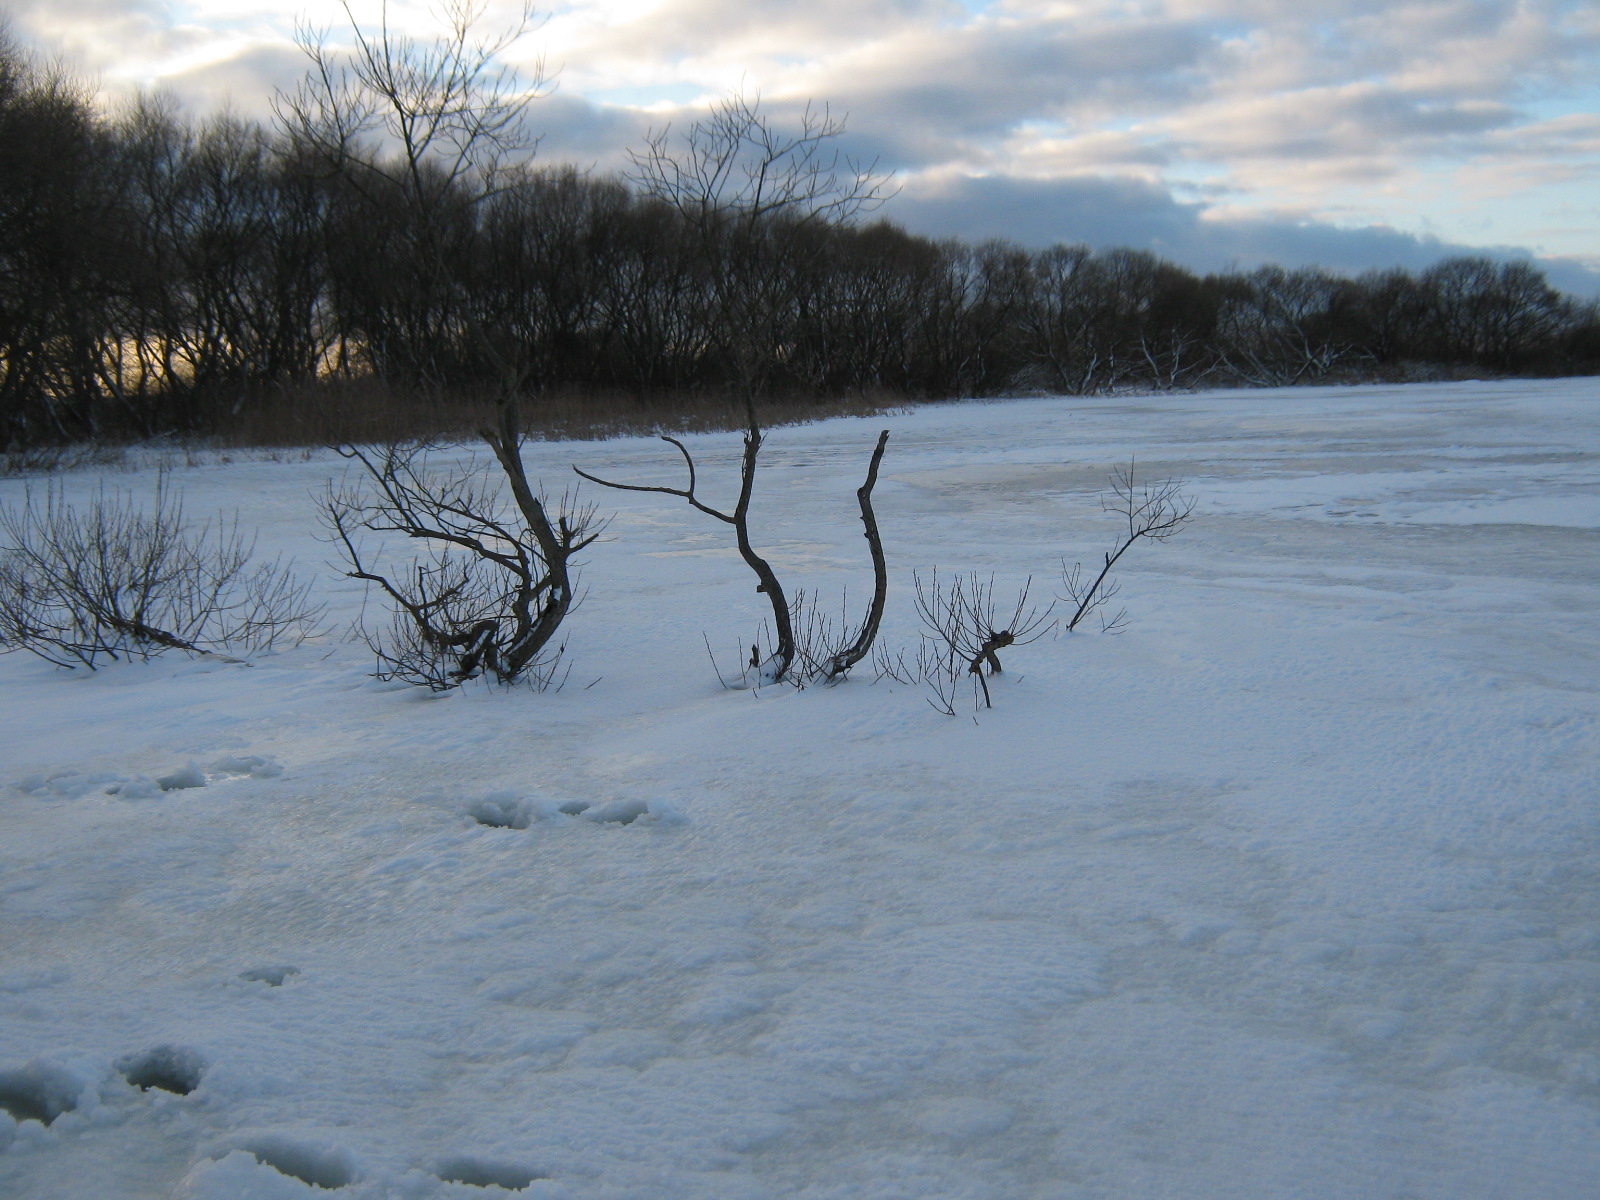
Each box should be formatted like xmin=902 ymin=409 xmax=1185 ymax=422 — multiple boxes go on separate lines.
xmin=0 ymin=379 xmax=1600 ymax=1200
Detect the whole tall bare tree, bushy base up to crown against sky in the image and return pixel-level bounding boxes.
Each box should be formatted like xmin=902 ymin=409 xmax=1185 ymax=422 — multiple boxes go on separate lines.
xmin=277 ymin=0 xmax=598 ymax=686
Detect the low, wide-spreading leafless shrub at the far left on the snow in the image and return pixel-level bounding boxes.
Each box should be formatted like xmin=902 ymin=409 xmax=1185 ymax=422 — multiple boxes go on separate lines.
xmin=0 ymin=478 xmax=322 ymax=670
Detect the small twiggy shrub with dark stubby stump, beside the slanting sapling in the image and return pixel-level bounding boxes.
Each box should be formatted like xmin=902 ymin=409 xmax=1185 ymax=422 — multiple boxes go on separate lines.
xmin=908 ymin=568 xmax=1053 ymax=715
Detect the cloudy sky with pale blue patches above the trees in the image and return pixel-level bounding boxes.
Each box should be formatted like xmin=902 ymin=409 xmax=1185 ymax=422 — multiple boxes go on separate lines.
xmin=5 ymin=0 xmax=1600 ymax=294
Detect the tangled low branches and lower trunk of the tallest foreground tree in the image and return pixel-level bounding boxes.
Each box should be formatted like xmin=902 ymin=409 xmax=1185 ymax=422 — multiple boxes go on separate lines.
xmin=322 ymin=445 xmax=606 ymax=691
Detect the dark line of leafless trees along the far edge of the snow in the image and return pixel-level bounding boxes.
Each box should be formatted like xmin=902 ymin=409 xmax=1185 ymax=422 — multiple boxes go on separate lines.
xmin=0 ymin=45 xmax=1600 ymax=450
